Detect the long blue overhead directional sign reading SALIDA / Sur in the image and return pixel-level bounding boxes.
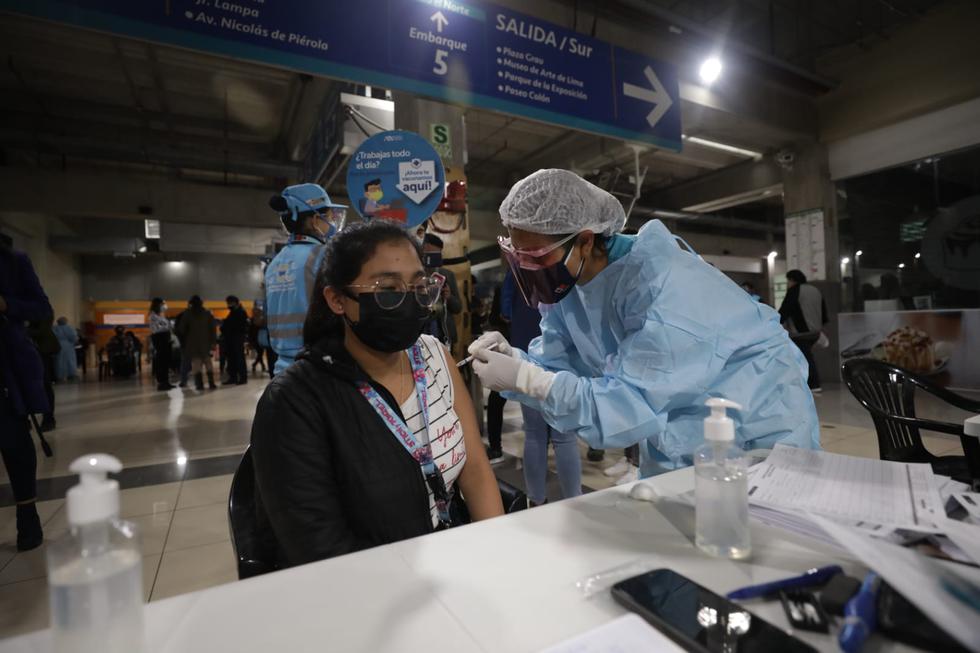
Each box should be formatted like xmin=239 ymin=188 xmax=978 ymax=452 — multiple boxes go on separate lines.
xmin=0 ymin=0 xmax=681 ymax=150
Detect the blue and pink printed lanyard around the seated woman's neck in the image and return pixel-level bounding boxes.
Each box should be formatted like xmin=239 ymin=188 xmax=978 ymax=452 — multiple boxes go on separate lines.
xmin=357 ymin=343 xmax=451 ymax=526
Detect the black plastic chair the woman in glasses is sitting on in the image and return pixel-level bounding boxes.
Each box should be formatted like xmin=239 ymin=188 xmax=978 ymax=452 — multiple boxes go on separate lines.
xmin=228 ymin=448 xmax=527 ymax=580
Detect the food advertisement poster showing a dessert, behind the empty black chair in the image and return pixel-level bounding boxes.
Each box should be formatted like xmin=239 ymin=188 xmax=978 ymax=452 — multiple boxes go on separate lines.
xmin=837 ymin=309 xmax=980 ymax=390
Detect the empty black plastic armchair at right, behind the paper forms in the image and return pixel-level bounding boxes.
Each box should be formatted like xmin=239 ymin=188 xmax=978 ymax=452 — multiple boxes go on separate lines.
xmin=841 ymin=358 xmax=980 ymax=487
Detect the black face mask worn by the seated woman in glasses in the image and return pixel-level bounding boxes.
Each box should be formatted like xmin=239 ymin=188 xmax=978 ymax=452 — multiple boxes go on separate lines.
xmin=344 ymin=291 xmax=432 ymax=354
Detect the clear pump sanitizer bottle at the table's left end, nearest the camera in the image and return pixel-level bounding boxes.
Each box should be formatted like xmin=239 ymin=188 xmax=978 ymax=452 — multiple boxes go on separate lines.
xmin=48 ymin=454 xmax=144 ymax=653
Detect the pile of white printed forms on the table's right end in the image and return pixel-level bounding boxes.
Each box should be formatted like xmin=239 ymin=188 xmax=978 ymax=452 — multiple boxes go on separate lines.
xmin=736 ymin=445 xmax=980 ymax=651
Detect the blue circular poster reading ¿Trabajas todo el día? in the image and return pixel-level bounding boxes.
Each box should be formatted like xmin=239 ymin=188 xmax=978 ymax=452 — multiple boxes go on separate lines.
xmin=347 ymin=130 xmax=446 ymax=228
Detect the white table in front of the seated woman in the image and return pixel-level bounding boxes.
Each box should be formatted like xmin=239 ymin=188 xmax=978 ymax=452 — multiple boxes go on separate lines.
xmin=0 ymin=469 xmax=940 ymax=653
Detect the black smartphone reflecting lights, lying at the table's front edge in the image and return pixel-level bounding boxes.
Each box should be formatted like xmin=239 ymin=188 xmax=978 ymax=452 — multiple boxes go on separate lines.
xmin=612 ymin=569 xmax=816 ymax=653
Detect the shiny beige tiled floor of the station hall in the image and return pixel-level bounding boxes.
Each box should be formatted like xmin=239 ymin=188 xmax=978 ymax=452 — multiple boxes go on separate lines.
xmin=0 ymin=370 xmax=963 ymax=637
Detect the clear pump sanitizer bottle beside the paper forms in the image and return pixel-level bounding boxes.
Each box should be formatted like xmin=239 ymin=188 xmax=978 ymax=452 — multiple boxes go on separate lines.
xmin=694 ymin=398 xmax=752 ymax=559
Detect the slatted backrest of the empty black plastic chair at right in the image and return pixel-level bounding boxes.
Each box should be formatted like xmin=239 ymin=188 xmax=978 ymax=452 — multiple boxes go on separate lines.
xmin=842 ymin=358 xmax=933 ymax=462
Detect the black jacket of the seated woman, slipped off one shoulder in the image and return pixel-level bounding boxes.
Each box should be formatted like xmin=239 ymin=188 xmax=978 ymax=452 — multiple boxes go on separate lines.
xmin=251 ymin=340 xmax=433 ymax=567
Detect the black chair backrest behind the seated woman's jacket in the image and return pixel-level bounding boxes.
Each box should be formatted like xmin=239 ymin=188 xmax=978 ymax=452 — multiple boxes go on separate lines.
xmin=228 ymin=449 xmax=276 ymax=580
